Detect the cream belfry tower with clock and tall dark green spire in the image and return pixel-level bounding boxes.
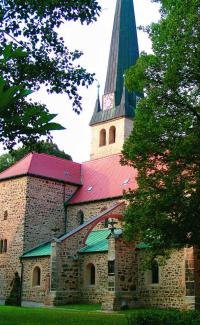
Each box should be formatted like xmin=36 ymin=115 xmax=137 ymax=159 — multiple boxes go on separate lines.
xmin=90 ymin=0 xmax=139 ymax=160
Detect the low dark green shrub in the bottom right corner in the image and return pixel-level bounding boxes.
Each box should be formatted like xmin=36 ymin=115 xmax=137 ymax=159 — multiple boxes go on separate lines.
xmin=127 ymin=310 xmax=200 ymax=325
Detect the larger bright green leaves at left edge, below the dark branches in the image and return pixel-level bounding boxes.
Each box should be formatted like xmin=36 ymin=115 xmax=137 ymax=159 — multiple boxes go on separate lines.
xmin=0 ymin=44 xmax=63 ymax=149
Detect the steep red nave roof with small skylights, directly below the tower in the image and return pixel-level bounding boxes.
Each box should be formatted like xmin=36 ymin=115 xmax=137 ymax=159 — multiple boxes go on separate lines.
xmin=69 ymin=154 xmax=137 ymax=204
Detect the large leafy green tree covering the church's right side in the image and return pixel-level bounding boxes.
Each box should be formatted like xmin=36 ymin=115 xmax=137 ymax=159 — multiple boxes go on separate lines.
xmin=122 ymin=0 xmax=200 ymax=253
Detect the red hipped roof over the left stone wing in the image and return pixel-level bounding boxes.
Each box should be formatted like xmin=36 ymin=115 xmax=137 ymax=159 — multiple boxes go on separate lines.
xmin=0 ymin=153 xmax=81 ymax=185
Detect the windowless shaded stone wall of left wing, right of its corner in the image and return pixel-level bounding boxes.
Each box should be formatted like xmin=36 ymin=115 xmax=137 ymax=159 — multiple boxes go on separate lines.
xmin=24 ymin=177 xmax=77 ymax=251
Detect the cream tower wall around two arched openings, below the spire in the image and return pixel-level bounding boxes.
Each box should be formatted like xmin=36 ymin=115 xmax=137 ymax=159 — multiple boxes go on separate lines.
xmin=90 ymin=118 xmax=133 ymax=159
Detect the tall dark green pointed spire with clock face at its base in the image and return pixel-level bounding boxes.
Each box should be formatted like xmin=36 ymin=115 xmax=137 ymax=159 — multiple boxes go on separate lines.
xmin=90 ymin=0 xmax=139 ymax=126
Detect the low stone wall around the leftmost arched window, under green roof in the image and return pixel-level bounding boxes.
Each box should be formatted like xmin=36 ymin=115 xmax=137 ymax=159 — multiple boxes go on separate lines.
xmin=22 ymin=256 xmax=50 ymax=303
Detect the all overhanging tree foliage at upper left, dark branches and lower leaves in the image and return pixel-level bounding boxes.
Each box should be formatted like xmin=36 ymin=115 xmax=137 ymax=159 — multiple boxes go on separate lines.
xmin=0 ymin=0 xmax=100 ymax=149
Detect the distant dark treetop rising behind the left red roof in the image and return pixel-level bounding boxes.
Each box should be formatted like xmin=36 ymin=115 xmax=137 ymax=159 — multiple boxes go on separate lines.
xmin=0 ymin=141 xmax=72 ymax=172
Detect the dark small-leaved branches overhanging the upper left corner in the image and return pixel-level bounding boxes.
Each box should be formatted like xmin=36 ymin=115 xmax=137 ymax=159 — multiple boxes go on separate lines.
xmin=0 ymin=0 xmax=100 ymax=113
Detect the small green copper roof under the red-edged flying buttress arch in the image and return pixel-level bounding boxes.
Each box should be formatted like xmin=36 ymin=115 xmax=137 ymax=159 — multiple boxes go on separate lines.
xmin=79 ymin=229 xmax=110 ymax=253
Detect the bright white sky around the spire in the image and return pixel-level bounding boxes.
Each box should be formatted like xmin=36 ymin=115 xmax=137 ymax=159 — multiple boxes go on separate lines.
xmin=0 ymin=0 xmax=159 ymax=162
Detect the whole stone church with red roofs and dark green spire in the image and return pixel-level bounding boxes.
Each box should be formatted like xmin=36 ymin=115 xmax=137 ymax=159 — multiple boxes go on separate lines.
xmin=0 ymin=0 xmax=200 ymax=310
